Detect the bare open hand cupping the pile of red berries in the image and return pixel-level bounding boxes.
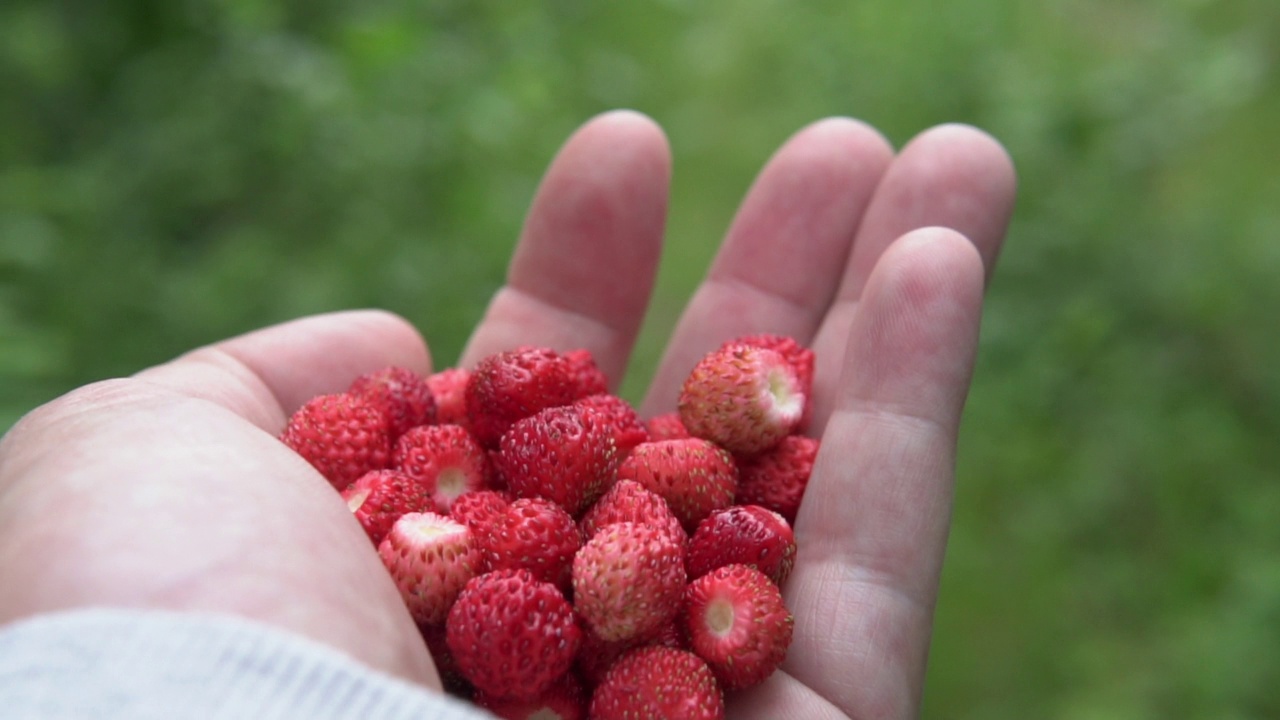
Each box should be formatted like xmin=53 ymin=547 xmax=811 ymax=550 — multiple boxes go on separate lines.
xmin=0 ymin=107 xmax=1014 ymax=719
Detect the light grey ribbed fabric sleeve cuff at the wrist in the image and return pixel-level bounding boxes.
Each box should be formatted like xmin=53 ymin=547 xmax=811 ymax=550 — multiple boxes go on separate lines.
xmin=0 ymin=609 xmax=493 ymax=720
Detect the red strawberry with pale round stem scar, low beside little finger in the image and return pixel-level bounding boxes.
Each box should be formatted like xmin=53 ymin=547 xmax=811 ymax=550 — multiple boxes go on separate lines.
xmin=685 ymin=565 xmax=795 ymax=689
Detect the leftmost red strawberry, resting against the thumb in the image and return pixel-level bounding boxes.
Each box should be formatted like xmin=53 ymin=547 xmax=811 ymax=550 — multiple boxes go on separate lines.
xmin=280 ymin=393 xmax=390 ymax=491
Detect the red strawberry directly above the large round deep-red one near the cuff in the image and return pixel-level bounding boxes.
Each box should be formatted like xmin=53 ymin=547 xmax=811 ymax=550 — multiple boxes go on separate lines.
xmin=484 ymin=497 xmax=582 ymax=591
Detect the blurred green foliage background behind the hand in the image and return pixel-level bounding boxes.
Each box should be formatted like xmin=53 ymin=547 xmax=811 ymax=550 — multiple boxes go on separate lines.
xmin=0 ymin=0 xmax=1280 ymax=720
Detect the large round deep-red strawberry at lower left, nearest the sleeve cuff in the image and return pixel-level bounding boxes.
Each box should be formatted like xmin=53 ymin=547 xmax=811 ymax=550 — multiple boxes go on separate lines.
xmin=447 ymin=570 xmax=582 ymax=700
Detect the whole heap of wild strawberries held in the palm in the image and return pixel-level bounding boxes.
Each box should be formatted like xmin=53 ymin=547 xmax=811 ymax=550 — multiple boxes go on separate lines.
xmin=280 ymin=334 xmax=818 ymax=720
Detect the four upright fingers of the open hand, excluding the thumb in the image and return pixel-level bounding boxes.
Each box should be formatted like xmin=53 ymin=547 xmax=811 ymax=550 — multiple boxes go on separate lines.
xmin=463 ymin=115 xmax=1014 ymax=720
